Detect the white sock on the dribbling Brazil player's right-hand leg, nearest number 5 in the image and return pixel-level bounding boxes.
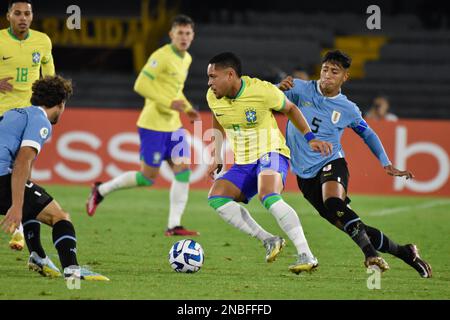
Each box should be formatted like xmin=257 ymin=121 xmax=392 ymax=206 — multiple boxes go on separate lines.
xmin=269 ymin=199 xmax=313 ymax=257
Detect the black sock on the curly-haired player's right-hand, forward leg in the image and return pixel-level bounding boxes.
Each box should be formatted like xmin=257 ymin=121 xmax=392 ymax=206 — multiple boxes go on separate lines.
xmin=53 ymin=220 xmax=78 ymax=269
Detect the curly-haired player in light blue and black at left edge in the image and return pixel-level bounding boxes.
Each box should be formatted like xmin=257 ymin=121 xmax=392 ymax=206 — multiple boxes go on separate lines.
xmin=0 ymin=76 xmax=109 ymax=280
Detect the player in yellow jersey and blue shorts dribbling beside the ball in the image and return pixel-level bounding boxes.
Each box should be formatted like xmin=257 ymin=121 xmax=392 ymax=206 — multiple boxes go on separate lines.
xmin=207 ymin=52 xmax=332 ymax=273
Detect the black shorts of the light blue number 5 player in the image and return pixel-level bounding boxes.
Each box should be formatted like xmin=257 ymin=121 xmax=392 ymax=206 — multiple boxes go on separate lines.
xmin=297 ymin=158 xmax=350 ymax=210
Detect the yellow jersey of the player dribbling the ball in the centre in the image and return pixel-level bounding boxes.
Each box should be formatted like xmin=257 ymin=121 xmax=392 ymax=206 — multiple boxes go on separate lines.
xmin=206 ymin=76 xmax=290 ymax=164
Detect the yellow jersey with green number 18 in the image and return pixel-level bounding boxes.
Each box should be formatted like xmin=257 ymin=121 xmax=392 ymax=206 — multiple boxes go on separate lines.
xmin=0 ymin=28 xmax=55 ymax=115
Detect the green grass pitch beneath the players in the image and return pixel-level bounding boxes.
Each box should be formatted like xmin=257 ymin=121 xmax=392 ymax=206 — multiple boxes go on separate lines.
xmin=0 ymin=186 xmax=450 ymax=300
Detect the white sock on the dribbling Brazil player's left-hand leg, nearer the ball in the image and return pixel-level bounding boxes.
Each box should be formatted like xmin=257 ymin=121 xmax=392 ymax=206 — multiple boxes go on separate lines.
xmin=216 ymin=201 xmax=274 ymax=241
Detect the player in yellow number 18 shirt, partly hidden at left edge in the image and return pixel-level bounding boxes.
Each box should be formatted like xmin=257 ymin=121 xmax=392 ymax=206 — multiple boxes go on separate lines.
xmin=0 ymin=0 xmax=55 ymax=250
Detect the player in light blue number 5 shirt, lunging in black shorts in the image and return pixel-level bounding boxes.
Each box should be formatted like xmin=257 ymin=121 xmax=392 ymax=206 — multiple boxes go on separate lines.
xmin=279 ymin=50 xmax=431 ymax=278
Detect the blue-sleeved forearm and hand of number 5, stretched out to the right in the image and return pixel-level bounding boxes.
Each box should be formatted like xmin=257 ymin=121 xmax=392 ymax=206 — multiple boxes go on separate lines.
xmin=351 ymin=119 xmax=414 ymax=179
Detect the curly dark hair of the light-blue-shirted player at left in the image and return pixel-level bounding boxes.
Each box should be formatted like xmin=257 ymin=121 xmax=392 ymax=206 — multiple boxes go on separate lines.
xmin=31 ymin=75 xmax=73 ymax=108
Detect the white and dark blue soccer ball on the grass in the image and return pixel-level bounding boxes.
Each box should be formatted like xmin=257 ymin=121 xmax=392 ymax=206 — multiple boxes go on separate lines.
xmin=169 ymin=239 xmax=204 ymax=273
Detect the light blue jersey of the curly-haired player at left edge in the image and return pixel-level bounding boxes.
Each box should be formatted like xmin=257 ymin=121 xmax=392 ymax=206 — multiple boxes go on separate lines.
xmin=0 ymin=106 xmax=52 ymax=176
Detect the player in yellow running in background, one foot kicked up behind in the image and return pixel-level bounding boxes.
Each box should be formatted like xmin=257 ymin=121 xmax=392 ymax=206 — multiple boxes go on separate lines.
xmin=86 ymin=15 xmax=200 ymax=236
